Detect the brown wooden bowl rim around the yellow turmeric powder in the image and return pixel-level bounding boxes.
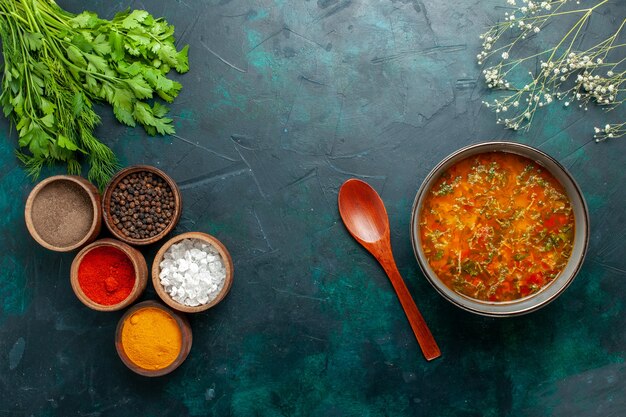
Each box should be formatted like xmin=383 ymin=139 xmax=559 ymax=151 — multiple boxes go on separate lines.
xmin=115 ymin=300 xmax=193 ymax=377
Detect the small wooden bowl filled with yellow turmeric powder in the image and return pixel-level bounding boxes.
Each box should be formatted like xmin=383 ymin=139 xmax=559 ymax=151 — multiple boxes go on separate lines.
xmin=115 ymin=301 xmax=192 ymax=377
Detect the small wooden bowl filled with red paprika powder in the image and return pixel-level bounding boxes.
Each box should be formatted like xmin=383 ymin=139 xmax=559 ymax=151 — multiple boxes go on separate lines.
xmin=70 ymin=239 xmax=148 ymax=311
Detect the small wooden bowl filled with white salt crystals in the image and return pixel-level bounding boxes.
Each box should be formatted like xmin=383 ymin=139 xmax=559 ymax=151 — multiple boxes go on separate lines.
xmin=152 ymin=232 xmax=233 ymax=313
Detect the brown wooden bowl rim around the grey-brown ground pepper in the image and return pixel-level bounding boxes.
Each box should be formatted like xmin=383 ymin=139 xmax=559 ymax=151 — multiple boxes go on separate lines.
xmin=24 ymin=175 xmax=102 ymax=252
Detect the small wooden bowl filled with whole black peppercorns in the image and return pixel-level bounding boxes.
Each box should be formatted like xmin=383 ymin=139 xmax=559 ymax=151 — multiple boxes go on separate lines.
xmin=102 ymin=165 xmax=182 ymax=245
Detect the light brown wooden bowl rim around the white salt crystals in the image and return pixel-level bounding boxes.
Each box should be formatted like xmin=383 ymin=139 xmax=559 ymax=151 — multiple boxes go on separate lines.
xmin=152 ymin=232 xmax=234 ymax=313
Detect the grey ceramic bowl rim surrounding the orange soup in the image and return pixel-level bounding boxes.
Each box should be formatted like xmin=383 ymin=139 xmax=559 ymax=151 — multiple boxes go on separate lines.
xmin=411 ymin=142 xmax=589 ymax=317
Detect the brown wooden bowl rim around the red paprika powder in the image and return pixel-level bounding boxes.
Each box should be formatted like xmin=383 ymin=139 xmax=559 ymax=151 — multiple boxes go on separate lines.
xmin=70 ymin=238 xmax=148 ymax=311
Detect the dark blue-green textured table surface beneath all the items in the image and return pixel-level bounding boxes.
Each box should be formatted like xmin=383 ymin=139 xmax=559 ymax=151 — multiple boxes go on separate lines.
xmin=0 ymin=0 xmax=626 ymax=417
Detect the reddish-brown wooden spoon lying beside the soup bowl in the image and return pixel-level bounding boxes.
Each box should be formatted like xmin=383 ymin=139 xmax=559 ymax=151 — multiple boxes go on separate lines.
xmin=339 ymin=178 xmax=441 ymax=361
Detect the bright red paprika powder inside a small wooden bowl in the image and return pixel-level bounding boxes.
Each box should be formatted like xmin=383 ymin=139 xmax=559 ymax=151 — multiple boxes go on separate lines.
xmin=78 ymin=246 xmax=135 ymax=306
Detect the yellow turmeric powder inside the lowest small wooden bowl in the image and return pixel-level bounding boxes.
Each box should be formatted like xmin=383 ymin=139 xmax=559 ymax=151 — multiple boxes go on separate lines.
xmin=121 ymin=307 xmax=182 ymax=370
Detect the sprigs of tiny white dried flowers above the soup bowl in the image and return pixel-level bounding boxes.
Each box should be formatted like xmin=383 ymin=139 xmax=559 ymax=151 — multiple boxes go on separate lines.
xmin=476 ymin=0 xmax=626 ymax=142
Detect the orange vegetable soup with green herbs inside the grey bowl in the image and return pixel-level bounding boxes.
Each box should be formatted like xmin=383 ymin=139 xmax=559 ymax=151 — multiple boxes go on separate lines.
xmin=420 ymin=152 xmax=574 ymax=301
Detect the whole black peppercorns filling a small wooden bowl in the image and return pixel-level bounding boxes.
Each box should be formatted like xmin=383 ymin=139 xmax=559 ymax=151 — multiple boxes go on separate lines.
xmin=110 ymin=171 xmax=176 ymax=239
